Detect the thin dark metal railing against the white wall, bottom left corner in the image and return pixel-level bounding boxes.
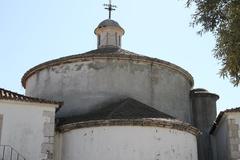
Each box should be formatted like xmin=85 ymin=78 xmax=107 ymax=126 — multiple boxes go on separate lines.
xmin=0 ymin=145 xmax=26 ymax=160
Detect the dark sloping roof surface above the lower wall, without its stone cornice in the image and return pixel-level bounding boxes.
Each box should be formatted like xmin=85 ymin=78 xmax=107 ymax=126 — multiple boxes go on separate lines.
xmin=57 ymin=98 xmax=175 ymax=126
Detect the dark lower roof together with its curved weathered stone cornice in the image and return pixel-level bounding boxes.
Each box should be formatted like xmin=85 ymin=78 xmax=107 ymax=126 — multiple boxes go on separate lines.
xmin=56 ymin=98 xmax=199 ymax=135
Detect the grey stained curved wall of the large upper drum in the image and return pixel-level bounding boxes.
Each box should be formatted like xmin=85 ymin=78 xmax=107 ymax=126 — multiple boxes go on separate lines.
xmin=26 ymin=57 xmax=192 ymax=122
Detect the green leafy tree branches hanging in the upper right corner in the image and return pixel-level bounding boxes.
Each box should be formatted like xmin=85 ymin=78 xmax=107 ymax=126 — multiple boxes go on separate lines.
xmin=187 ymin=0 xmax=240 ymax=86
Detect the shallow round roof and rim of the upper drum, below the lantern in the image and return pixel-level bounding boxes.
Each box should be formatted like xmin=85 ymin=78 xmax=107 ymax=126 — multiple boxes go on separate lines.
xmin=22 ymin=47 xmax=194 ymax=88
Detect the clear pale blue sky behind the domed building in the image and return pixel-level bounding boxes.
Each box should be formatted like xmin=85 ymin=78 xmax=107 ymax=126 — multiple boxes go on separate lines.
xmin=0 ymin=0 xmax=240 ymax=111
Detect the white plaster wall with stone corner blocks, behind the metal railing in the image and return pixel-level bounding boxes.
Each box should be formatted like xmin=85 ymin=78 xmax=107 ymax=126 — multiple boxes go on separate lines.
xmin=0 ymin=100 xmax=56 ymax=160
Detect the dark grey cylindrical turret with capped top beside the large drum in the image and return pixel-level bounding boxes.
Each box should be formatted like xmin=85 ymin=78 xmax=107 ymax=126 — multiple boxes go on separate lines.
xmin=190 ymin=89 xmax=219 ymax=160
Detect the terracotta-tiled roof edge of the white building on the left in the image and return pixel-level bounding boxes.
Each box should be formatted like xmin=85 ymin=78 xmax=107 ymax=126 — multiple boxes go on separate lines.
xmin=0 ymin=88 xmax=62 ymax=106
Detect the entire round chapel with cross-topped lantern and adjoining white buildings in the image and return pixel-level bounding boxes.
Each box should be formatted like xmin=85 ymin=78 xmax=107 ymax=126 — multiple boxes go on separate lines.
xmin=0 ymin=3 xmax=240 ymax=160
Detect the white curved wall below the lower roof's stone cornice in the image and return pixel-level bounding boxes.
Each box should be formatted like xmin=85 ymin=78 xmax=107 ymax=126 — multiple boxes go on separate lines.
xmin=59 ymin=126 xmax=197 ymax=160
